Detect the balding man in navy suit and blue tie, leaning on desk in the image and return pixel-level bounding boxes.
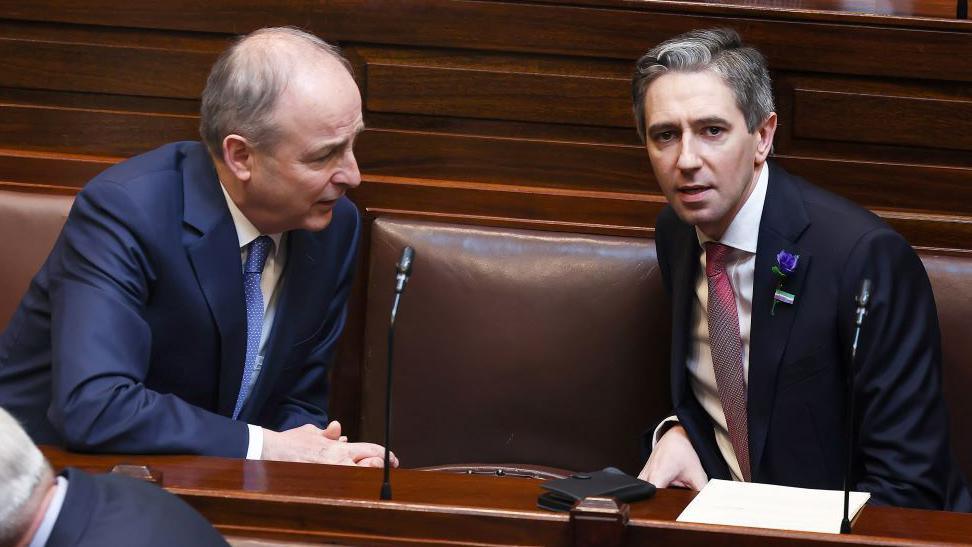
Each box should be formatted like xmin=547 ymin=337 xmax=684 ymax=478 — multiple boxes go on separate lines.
xmin=0 ymin=28 xmax=396 ymax=466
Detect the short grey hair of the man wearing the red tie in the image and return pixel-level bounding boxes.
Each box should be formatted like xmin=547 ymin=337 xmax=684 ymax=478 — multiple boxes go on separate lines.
xmin=631 ymin=28 xmax=776 ymax=142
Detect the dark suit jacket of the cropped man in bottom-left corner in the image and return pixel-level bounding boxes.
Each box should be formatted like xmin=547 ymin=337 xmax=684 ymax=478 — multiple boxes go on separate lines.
xmin=47 ymin=468 xmax=227 ymax=547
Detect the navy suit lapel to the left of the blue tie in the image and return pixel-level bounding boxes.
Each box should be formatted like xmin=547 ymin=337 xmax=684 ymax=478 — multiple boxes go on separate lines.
xmin=183 ymin=148 xmax=246 ymax=416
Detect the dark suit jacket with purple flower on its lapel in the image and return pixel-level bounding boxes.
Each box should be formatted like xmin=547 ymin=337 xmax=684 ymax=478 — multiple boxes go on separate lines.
xmin=657 ymin=164 xmax=972 ymax=510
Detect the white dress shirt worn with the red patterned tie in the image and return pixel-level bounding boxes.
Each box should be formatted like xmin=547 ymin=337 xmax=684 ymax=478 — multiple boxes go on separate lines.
xmin=654 ymin=163 xmax=769 ymax=481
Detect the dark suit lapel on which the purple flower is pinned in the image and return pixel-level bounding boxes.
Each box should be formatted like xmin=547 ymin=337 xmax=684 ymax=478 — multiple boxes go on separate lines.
xmin=748 ymin=164 xmax=811 ymax=480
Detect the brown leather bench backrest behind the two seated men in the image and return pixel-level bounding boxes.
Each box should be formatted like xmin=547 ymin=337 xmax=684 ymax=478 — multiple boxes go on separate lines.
xmin=0 ymin=191 xmax=972 ymax=484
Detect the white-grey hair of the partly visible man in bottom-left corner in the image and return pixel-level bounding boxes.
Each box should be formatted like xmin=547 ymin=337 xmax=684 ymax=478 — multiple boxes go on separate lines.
xmin=0 ymin=408 xmax=51 ymax=545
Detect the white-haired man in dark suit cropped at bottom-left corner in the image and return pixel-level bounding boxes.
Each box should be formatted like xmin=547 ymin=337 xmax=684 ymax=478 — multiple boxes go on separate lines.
xmin=0 ymin=408 xmax=226 ymax=547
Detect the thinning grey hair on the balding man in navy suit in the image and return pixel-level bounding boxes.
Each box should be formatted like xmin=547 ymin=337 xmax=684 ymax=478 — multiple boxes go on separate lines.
xmin=199 ymin=27 xmax=352 ymax=158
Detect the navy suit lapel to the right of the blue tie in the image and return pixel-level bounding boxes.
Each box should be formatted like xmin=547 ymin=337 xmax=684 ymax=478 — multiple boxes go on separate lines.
xmin=237 ymin=230 xmax=327 ymax=420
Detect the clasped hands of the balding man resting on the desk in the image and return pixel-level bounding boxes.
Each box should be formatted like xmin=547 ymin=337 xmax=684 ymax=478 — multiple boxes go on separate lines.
xmin=263 ymin=421 xmax=398 ymax=467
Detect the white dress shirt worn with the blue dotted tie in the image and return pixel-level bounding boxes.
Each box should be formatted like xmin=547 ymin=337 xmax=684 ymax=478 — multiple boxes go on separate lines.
xmin=220 ymin=182 xmax=287 ymax=460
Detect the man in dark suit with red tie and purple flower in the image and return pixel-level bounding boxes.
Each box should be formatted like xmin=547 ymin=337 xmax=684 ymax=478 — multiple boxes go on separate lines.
xmin=633 ymin=29 xmax=972 ymax=510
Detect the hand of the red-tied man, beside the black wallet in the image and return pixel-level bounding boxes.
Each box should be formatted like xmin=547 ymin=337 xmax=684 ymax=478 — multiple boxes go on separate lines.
xmin=638 ymin=425 xmax=709 ymax=490
